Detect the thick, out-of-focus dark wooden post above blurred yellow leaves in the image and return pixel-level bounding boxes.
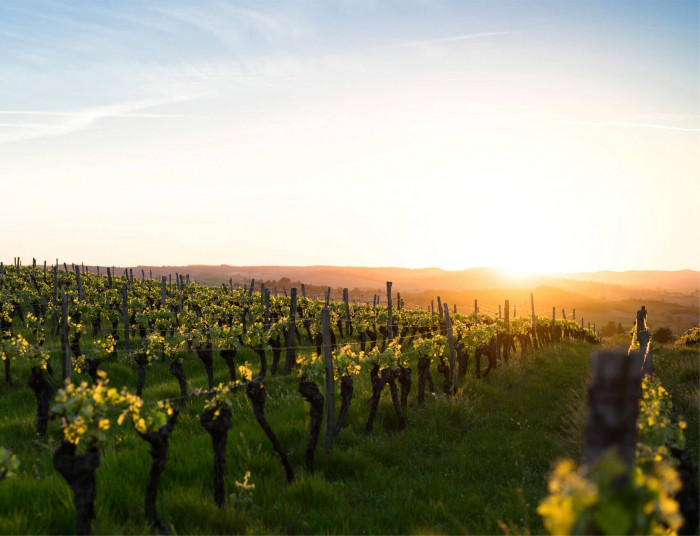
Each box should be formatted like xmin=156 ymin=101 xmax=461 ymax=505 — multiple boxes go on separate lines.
xmin=584 ymin=350 xmax=642 ymax=467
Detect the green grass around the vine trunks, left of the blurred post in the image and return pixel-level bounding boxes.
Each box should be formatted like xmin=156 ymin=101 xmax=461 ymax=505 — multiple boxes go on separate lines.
xmin=0 ymin=342 xmax=591 ymax=534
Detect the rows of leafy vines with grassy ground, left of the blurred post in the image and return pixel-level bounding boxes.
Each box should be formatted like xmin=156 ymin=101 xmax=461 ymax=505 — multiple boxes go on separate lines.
xmin=0 ymin=263 xmax=692 ymax=534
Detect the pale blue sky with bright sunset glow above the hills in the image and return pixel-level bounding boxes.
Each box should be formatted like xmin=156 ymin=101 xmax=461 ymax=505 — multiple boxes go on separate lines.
xmin=0 ymin=0 xmax=700 ymax=273
